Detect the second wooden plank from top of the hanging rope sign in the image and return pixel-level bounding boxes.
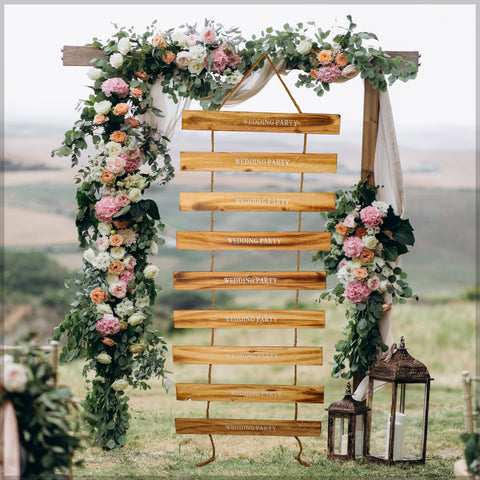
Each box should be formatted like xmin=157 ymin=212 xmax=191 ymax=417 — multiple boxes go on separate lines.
xmin=180 ymin=152 xmax=337 ymax=173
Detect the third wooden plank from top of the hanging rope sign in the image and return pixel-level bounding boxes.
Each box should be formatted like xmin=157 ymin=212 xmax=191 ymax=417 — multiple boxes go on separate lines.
xmin=180 ymin=192 xmax=335 ymax=212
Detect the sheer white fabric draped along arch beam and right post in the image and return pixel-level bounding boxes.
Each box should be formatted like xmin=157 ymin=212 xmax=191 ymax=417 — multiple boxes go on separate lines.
xmin=144 ymin=66 xmax=405 ymax=400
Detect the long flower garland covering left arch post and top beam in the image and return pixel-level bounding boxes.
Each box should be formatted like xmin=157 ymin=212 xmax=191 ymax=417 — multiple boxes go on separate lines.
xmin=52 ymin=16 xmax=416 ymax=448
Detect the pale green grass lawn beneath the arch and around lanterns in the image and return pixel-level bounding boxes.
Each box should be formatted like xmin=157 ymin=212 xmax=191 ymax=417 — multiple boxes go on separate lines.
xmin=60 ymin=301 xmax=475 ymax=479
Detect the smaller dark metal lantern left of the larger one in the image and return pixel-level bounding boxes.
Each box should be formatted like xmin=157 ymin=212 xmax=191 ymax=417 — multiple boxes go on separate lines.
xmin=327 ymin=383 xmax=369 ymax=460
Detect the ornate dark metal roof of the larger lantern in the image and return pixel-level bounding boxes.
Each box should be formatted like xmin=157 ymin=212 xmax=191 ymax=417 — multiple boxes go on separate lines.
xmin=368 ymin=337 xmax=433 ymax=383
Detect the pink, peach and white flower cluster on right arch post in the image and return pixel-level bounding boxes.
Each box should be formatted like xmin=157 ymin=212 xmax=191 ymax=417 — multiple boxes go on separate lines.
xmin=314 ymin=182 xmax=417 ymax=378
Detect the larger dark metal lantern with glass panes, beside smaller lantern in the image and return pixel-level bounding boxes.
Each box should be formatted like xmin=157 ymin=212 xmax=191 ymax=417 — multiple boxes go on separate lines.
xmin=367 ymin=337 xmax=433 ymax=464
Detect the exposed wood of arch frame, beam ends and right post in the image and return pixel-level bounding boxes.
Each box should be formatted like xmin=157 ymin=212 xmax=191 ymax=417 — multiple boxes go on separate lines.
xmin=62 ymin=45 xmax=420 ymax=390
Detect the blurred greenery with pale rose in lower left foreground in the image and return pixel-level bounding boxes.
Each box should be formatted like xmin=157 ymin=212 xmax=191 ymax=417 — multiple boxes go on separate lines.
xmin=0 ymin=347 xmax=80 ymax=480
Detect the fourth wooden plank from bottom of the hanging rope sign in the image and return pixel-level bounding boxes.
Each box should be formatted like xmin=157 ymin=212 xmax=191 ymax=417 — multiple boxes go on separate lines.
xmin=173 ymin=310 xmax=325 ymax=328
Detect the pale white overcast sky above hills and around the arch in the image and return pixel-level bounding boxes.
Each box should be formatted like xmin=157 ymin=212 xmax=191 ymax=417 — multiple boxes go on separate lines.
xmin=4 ymin=3 xmax=476 ymax=144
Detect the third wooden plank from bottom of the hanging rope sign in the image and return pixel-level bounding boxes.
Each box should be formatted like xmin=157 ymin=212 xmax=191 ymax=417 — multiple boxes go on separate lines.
xmin=172 ymin=346 xmax=323 ymax=365
